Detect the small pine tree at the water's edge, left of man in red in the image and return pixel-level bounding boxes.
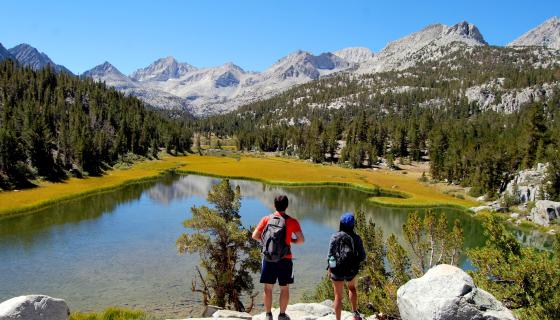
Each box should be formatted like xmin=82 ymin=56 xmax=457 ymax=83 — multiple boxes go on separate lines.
xmin=177 ymin=180 xmax=260 ymax=311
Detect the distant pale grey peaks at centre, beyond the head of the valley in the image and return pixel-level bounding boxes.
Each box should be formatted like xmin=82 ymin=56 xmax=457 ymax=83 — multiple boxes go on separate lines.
xmin=83 ymin=50 xmax=354 ymax=114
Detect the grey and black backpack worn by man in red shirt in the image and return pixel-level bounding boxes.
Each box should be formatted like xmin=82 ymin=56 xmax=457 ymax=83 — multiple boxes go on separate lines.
xmin=261 ymin=214 xmax=290 ymax=262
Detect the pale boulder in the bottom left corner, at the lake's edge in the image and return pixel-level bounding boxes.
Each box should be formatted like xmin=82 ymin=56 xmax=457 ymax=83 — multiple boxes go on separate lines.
xmin=0 ymin=295 xmax=70 ymax=320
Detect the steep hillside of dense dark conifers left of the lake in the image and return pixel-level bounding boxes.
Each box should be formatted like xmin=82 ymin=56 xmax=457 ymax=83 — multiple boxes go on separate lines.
xmin=0 ymin=60 xmax=191 ymax=189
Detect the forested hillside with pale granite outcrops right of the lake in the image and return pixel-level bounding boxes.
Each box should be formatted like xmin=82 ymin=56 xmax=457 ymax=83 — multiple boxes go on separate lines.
xmin=198 ymin=42 xmax=560 ymax=195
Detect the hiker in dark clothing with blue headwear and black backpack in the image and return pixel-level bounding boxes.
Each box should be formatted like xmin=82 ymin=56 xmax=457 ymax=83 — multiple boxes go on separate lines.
xmin=328 ymin=213 xmax=366 ymax=320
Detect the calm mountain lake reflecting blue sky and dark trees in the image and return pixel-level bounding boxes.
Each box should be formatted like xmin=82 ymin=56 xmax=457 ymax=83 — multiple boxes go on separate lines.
xmin=0 ymin=175 xmax=546 ymax=316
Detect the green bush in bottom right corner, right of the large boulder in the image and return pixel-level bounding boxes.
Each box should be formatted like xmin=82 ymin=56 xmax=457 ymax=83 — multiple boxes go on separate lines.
xmin=468 ymin=217 xmax=560 ymax=320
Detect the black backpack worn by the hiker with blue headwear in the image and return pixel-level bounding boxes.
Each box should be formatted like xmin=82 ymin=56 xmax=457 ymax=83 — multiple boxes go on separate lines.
xmin=329 ymin=231 xmax=359 ymax=274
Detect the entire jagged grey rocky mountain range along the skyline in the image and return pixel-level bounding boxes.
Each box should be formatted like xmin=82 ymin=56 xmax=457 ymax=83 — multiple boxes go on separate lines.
xmin=0 ymin=17 xmax=560 ymax=115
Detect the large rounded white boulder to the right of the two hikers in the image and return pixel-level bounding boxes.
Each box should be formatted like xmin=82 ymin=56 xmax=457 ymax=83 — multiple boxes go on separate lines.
xmin=397 ymin=264 xmax=515 ymax=320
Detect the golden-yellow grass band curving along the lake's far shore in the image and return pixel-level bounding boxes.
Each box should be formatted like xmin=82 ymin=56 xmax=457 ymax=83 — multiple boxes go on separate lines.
xmin=0 ymin=155 xmax=475 ymax=219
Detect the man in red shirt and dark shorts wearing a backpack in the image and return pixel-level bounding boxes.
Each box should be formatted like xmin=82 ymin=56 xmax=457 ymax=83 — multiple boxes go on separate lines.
xmin=252 ymin=195 xmax=305 ymax=320
